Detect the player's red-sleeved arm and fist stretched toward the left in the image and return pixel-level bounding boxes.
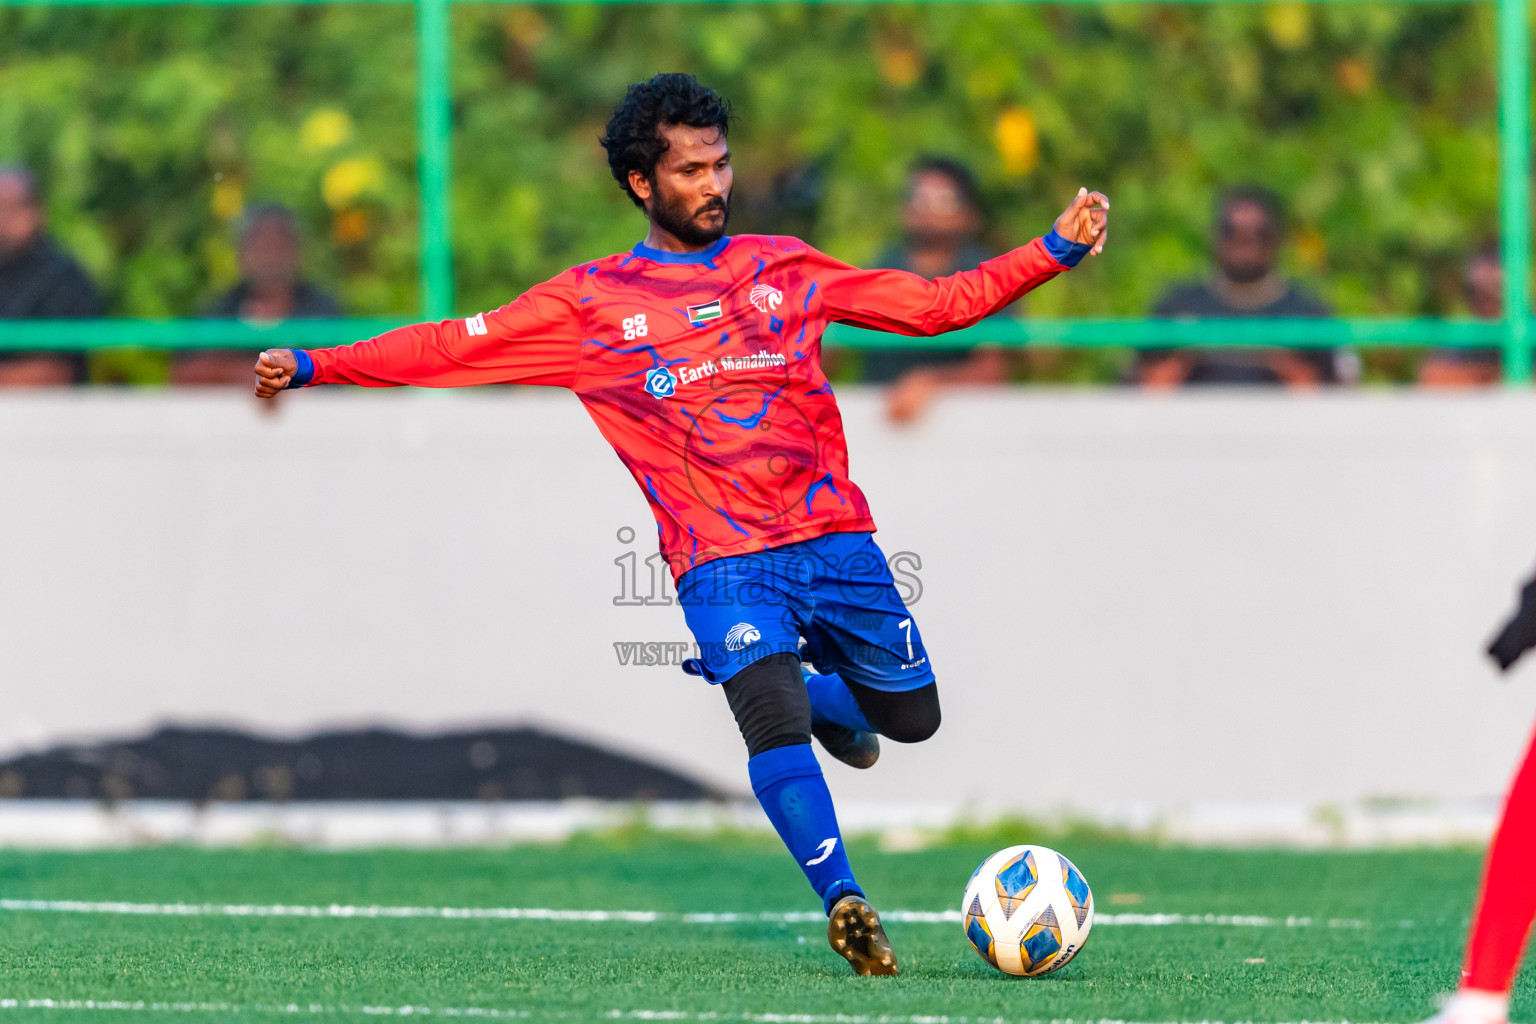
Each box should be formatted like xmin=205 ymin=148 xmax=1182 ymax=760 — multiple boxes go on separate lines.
xmin=255 ymin=272 xmax=581 ymax=398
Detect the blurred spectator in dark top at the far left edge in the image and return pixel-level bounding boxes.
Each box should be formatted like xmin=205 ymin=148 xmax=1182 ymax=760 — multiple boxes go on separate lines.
xmin=0 ymin=166 xmax=101 ymax=387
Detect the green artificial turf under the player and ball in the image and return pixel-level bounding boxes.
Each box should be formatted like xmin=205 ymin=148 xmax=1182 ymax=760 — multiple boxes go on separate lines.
xmin=0 ymin=831 xmax=1536 ymax=1024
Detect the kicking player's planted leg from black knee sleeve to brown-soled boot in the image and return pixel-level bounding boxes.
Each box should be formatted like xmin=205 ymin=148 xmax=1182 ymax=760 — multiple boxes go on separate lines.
xmin=722 ymin=652 xmax=897 ymax=975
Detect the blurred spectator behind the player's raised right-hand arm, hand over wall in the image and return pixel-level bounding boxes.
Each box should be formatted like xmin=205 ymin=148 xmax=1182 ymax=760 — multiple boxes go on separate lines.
xmin=863 ymin=157 xmax=1008 ymax=422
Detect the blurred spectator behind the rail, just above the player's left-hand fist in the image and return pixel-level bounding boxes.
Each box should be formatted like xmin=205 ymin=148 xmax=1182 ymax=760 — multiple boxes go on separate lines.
xmin=170 ymin=203 xmax=341 ymax=387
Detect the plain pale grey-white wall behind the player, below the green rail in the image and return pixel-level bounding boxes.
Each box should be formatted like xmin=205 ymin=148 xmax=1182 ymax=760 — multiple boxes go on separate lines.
xmin=0 ymin=388 xmax=1536 ymax=829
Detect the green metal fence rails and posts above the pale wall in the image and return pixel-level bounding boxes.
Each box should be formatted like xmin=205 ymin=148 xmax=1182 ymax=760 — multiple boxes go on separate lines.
xmin=0 ymin=0 xmax=1531 ymax=384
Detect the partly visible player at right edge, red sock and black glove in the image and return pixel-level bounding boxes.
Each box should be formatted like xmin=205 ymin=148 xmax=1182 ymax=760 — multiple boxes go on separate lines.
xmin=1433 ymin=580 xmax=1536 ymax=1024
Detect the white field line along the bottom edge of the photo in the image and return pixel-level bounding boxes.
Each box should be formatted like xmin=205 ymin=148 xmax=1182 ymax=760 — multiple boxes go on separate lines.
xmin=0 ymin=999 xmax=1406 ymax=1024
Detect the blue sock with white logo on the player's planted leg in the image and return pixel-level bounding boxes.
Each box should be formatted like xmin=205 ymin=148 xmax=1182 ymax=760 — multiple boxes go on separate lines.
xmin=746 ymin=743 xmax=863 ymax=913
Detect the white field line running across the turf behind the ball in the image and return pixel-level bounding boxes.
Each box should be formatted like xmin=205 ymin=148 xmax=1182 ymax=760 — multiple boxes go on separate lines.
xmin=0 ymin=900 xmax=1366 ymax=927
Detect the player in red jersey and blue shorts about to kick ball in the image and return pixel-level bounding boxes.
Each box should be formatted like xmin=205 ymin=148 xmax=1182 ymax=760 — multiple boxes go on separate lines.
xmin=257 ymin=74 xmax=1109 ymax=975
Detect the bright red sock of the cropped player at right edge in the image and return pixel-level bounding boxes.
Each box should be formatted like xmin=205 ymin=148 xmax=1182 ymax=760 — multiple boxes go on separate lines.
xmin=1461 ymin=724 xmax=1536 ymax=995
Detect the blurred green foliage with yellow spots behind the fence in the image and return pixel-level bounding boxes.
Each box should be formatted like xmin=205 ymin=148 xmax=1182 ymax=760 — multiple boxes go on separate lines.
xmin=0 ymin=0 xmax=1498 ymax=323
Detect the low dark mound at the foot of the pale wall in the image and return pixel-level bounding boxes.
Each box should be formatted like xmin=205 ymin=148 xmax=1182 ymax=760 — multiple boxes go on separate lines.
xmin=0 ymin=726 xmax=722 ymax=801
